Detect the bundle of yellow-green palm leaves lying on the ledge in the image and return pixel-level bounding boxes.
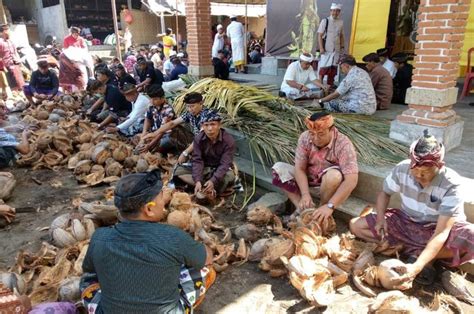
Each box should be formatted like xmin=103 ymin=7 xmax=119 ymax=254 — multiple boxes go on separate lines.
xmin=174 ymin=76 xmax=407 ymax=165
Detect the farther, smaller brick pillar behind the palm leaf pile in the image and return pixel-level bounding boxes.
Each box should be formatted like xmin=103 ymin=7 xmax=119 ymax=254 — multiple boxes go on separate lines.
xmin=186 ymin=0 xmax=214 ymax=76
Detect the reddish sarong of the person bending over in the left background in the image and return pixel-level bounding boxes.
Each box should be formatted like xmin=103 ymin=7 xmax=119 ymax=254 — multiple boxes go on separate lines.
xmin=59 ymin=53 xmax=87 ymax=91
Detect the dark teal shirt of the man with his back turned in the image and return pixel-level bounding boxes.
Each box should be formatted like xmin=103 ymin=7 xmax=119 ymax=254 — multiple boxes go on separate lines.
xmin=82 ymin=221 xmax=206 ymax=313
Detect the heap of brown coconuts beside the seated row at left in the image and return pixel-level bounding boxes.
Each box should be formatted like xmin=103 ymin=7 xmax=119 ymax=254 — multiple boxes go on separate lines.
xmin=17 ymin=94 xmax=169 ymax=186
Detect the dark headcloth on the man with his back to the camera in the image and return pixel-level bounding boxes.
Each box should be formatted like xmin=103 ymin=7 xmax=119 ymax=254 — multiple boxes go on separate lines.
xmin=114 ymin=170 xmax=163 ymax=214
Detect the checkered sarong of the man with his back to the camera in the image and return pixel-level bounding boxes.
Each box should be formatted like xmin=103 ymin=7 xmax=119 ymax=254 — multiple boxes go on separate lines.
xmin=80 ymin=266 xmax=216 ymax=314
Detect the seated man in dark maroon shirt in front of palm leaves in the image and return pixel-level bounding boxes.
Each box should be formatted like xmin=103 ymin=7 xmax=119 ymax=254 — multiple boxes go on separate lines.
xmin=175 ymin=110 xmax=235 ymax=196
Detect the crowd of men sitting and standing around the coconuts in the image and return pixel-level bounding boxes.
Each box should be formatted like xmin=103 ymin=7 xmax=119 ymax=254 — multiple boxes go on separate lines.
xmin=0 ymin=4 xmax=474 ymax=313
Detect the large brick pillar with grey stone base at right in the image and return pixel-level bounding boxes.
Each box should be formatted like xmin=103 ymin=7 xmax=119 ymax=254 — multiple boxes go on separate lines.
xmin=390 ymin=0 xmax=471 ymax=150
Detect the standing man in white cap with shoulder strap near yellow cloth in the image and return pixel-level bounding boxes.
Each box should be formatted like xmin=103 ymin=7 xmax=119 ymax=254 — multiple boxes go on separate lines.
xmin=318 ymin=3 xmax=344 ymax=85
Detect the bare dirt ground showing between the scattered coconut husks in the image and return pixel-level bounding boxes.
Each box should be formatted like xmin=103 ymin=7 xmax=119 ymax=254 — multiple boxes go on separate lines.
xmin=0 ymin=168 xmax=474 ymax=314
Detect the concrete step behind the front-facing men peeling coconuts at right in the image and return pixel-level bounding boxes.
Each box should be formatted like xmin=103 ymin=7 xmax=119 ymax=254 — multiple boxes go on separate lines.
xmin=234 ymin=156 xmax=474 ymax=222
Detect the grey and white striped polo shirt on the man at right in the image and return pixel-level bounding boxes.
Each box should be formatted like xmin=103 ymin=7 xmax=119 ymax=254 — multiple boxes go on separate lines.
xmin=383 ymin=160 xmax=466 ymax=222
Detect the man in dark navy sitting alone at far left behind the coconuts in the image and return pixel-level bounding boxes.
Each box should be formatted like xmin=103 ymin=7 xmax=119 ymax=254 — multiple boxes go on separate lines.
xmin=23 ymin=59 xmax=59 ymax=105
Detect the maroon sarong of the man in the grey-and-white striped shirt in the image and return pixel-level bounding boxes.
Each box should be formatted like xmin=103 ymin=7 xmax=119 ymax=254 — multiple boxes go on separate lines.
xmin=365 ymin=208 xmax=474 ymax=267
